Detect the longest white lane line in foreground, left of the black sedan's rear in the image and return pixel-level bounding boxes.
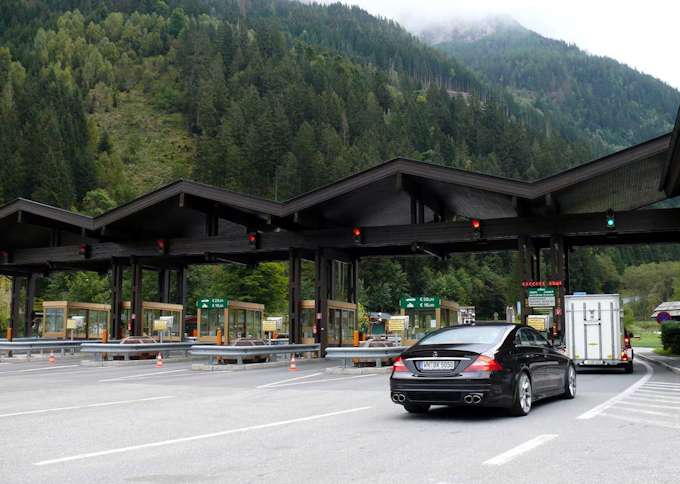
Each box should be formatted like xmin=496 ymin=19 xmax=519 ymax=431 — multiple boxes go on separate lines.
xmin=33 ymin=407 xmax=373 ymax=466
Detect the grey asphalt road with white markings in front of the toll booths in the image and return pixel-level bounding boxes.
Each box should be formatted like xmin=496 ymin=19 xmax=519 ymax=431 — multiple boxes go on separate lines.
xmin=0 ymin=359 xmax=680 ymax=484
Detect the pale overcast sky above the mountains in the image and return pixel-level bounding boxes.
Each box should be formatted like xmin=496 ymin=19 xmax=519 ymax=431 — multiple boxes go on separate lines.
xmin=310 ymin=0 xmax=680 ymax=89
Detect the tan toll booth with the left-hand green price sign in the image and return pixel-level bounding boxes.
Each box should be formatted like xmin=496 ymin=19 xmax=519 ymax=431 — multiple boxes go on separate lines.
xmin=196 ymin=298 xmax=264 ymax=345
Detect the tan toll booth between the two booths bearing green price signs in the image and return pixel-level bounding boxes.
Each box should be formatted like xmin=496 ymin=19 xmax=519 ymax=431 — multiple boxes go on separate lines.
xmin=300 ymin=299 xmax=358 ymax=346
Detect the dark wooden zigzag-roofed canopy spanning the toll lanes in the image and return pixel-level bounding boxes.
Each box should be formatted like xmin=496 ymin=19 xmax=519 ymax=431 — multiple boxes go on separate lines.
xmin=0 ymin=109 xmax=680 ymax=339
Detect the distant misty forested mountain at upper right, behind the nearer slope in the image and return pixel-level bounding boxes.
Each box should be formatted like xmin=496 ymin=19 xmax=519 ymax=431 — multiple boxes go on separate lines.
xmin=430 ymin=17 xmax=680 ymax=153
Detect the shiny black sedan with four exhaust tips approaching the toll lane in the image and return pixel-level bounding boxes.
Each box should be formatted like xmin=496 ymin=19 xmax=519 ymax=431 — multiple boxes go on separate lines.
xmin=390 ymin=323 xmax=576 ymax=416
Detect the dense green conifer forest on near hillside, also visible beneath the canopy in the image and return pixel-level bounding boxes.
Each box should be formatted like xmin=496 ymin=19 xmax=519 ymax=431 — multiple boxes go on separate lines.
xmin=0 ymin=0 xmax=674 ymax=326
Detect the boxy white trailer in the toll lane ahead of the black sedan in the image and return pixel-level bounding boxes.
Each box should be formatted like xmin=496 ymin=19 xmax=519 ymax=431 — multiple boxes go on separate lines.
xmin=564 ymin=294 xmax=633 ymax=373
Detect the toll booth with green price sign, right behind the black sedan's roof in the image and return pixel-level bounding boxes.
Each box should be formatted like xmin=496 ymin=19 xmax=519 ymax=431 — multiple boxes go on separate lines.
xmin=392 ymin=296 xmax=460 ymax=346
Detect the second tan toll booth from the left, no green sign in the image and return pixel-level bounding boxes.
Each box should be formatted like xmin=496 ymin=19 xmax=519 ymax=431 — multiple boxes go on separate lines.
xmin=122 ymin=301 xmax=184 ymax=342
